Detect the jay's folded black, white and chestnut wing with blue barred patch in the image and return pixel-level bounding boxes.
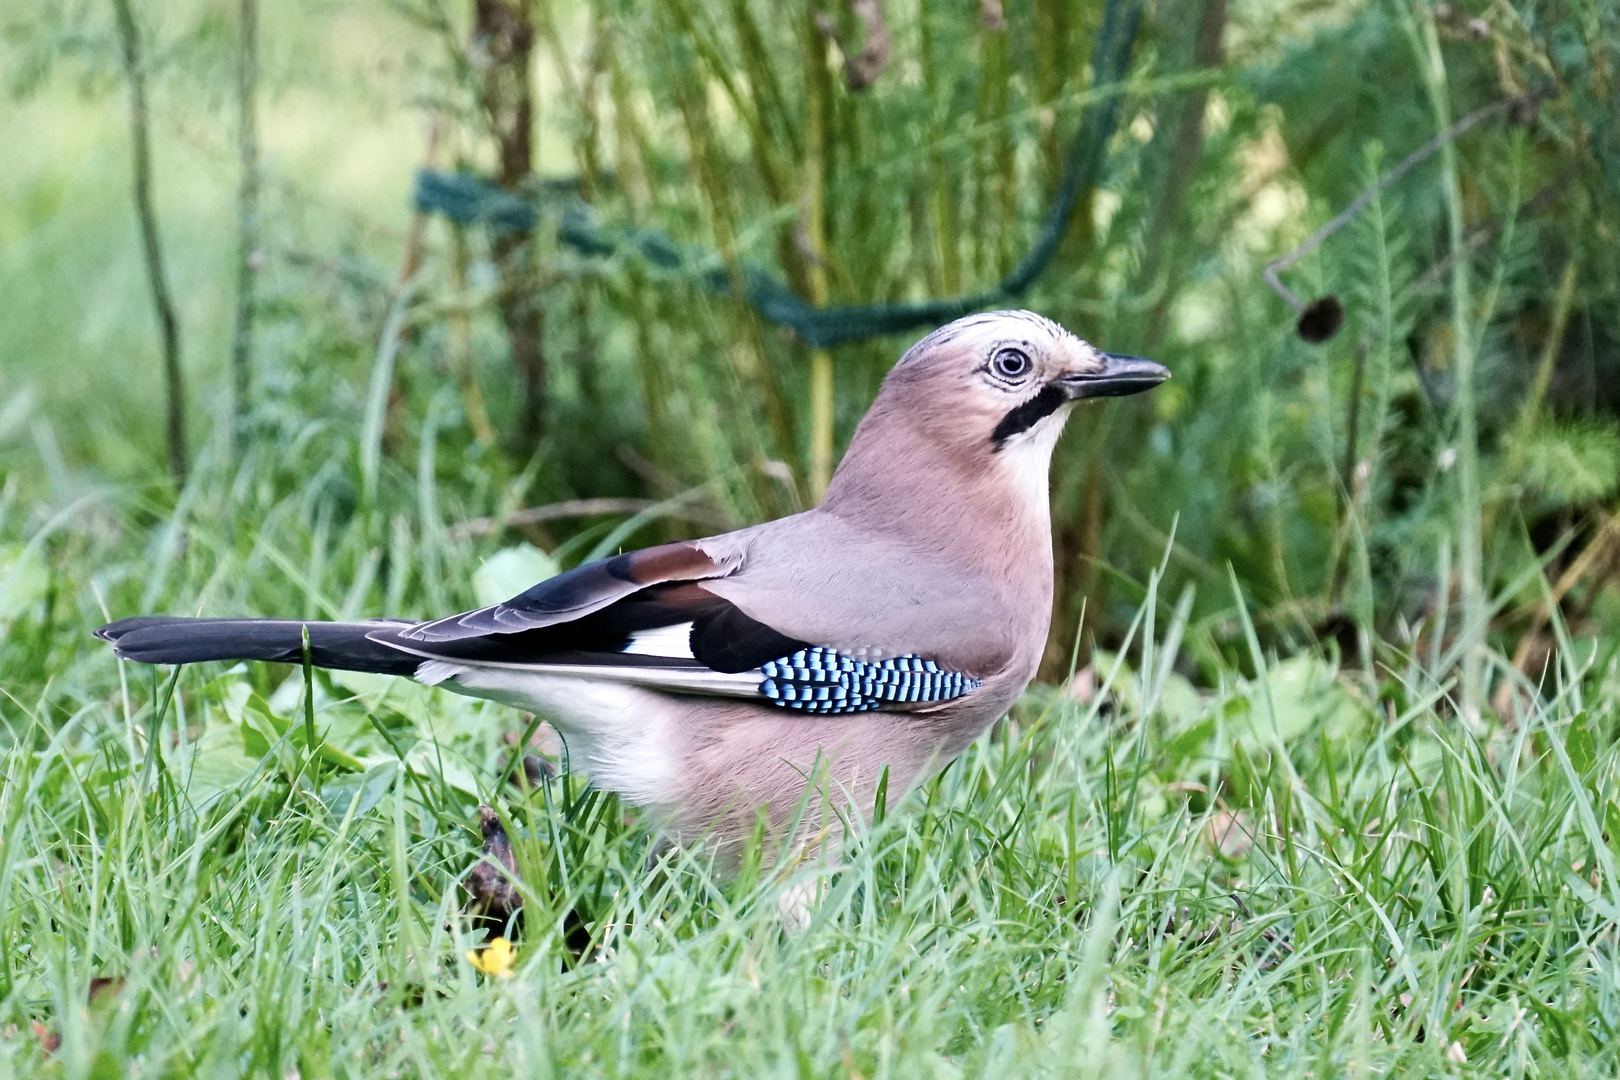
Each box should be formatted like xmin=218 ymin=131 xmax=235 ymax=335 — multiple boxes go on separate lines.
xmin=369 ymin=534 xmax=978 ymax=714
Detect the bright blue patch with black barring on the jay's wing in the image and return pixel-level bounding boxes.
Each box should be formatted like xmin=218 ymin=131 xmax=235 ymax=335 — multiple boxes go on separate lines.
xmin=760 ymin=644 xmax=978 ymax=714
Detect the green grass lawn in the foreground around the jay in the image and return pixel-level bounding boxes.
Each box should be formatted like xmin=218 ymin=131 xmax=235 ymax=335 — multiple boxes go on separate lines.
xmin=0 ymin=459 xmax=1620 ymax=1078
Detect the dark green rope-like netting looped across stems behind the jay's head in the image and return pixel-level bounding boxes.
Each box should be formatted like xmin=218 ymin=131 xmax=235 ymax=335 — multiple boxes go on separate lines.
xmin=415 ymin=0 xmax=1144 ymax=348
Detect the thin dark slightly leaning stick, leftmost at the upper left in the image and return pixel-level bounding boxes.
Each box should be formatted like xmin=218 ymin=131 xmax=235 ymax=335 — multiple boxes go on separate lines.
xmin=112 ymin=0 xmax=186 ymax=483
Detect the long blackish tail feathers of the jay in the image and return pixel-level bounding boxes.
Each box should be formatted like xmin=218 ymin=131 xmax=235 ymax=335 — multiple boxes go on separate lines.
xmin=96 ymin=615 xmax=421 ymax=675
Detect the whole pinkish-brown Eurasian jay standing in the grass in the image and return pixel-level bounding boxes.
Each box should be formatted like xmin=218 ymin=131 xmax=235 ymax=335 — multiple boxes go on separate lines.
xmin=96 ymin=311 xmax=1170 ymax=840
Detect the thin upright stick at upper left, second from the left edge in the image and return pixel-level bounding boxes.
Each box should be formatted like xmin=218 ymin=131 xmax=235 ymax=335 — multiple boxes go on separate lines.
xmin=230 ymin=0 xmax=262 ymax=461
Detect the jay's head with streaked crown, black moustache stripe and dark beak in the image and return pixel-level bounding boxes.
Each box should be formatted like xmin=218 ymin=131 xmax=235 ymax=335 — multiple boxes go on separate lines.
xmin=891 ymin=311 xmax=1170 ymax=491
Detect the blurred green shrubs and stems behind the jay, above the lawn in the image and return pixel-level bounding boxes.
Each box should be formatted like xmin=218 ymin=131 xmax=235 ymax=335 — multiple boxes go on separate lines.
xmin=0 ymin=0 xmax=1620 ymax=677
